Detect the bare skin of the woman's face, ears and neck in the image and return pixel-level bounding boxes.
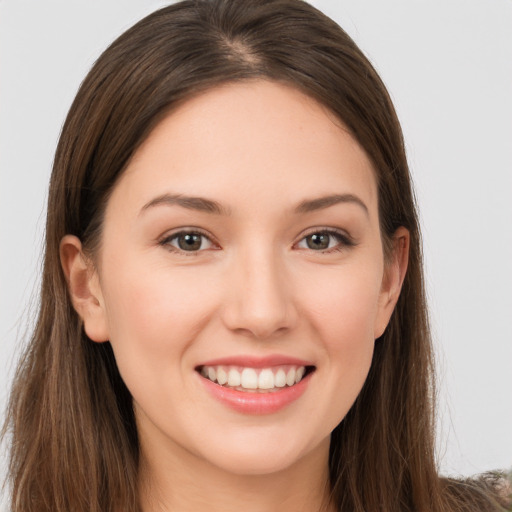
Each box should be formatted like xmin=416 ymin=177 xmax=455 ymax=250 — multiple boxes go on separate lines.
xmin=61 ymin=81 xmax=408 ymax=511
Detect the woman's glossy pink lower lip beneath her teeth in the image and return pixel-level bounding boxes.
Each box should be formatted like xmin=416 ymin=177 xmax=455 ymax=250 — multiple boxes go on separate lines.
xmin=199 ymin=374 xmax=312 ymax=414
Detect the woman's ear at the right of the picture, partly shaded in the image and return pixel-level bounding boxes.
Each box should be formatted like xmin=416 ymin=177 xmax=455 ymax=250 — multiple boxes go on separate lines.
xmin=374 ymin=227 xmax=410 ymax=339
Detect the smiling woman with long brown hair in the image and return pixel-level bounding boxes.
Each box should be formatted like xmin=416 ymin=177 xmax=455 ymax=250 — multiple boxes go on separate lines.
xmin=2 ymin=0 xmax=506 ymax=511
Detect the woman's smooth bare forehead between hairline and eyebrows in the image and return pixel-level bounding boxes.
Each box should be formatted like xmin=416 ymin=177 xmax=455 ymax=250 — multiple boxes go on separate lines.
xmin=114 ymin=81 xmax=377 ymax=219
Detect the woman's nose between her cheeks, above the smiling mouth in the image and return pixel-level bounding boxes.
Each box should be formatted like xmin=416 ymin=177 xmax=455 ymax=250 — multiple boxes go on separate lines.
xmin=223 ymin=244 xmax=298 ymax=339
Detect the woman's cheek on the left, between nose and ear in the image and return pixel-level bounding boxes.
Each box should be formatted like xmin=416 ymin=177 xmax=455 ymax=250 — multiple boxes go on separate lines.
xmin=100 ymin=261 xmax=218 ymax=377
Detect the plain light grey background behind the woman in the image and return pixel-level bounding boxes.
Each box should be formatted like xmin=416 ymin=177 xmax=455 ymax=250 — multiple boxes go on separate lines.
xmin=0 ymin=0 xmax=512 ymax=498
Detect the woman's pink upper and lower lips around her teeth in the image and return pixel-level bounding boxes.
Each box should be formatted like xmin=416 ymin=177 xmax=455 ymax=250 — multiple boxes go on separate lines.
xmin=198 ymin=355 xmax=313 ymax=415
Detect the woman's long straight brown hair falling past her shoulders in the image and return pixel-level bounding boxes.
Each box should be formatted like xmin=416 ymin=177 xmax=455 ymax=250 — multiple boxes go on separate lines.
xmin=6 ymin=0 xmax=508 ymax=512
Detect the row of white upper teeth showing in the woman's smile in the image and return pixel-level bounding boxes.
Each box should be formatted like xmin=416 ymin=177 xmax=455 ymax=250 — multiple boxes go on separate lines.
xmin=201 ymin=365 xmax=306 ymax=391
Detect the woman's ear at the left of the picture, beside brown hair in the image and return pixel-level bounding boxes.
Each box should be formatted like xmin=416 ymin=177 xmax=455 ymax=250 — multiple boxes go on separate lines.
xmin=60 ymin=235 xmax=109 ymax=342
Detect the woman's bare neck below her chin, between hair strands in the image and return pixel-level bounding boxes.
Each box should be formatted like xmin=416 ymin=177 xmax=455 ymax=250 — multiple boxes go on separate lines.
xmin=141 ymin=439 xmax=334 ymax=512
